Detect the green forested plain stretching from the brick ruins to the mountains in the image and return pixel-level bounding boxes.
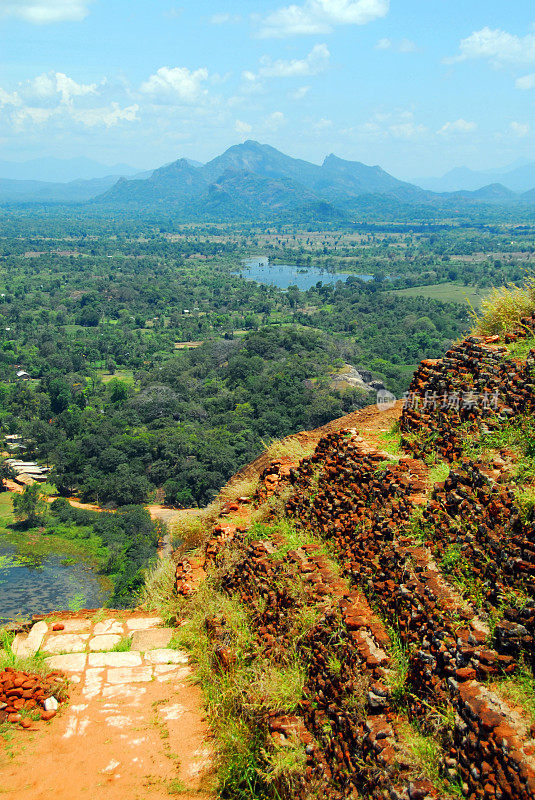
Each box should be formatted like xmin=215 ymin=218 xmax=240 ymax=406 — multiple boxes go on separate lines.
xmin=0 ymin=210 xmax=535 ymax=600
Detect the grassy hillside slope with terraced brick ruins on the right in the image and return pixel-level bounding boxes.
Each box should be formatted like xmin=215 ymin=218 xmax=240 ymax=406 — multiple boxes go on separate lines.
xmin=171 ymin=318 xmax=535 ymax=800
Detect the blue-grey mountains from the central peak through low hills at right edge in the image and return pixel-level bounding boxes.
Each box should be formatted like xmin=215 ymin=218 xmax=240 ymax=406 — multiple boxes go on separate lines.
xmin=94 ymin=141 xmax=535 ymax=218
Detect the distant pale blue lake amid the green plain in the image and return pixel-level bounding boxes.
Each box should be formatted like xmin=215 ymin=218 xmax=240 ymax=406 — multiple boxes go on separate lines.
xmin=240 ymin=256 xmax=373 ymax=292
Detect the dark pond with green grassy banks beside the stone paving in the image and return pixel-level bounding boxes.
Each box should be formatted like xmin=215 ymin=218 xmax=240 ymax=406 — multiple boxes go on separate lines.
xmin=0 ymin=531 xmax=111 ymax=623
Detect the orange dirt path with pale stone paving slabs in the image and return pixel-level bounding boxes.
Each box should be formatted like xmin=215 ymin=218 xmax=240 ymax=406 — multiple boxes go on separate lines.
xmin=0 ymin=612 xmax=214 ymax=800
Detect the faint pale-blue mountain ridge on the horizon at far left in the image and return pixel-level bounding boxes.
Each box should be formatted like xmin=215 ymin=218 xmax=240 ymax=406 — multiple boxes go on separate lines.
xmin=0 ymin=156 xmax=140 ymax=183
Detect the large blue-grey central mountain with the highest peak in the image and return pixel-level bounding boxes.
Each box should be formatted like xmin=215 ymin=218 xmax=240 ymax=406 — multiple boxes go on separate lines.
xmin=97 ymin=141 xmax=429 ymax=216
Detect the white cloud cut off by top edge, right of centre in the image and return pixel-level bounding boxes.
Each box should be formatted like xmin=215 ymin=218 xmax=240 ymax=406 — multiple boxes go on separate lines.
xmin=260 ymin=0 xmax=390 ymax=38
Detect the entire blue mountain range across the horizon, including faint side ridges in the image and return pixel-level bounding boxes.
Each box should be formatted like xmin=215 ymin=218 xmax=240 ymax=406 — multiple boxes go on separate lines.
xmin=0 ymin=141 xmax=535 ymax=214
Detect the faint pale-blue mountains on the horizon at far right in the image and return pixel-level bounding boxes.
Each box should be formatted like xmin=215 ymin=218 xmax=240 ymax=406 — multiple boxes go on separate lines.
xmin=417 ymin=160 xmax=535 ymax=192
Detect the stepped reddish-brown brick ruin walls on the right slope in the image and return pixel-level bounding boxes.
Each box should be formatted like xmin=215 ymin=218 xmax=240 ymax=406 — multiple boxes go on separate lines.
xmin=177 ymin=334 xmax=535 ymax=800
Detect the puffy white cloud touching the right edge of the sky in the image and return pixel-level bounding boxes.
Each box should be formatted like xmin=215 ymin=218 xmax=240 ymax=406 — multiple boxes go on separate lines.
xmin=447 ymin=27 xmax=535 ymax=65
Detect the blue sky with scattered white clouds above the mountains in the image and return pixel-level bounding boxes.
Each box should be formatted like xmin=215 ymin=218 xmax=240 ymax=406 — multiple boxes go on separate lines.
xmin=0 ymin=0 xmax=535 ymax=177
